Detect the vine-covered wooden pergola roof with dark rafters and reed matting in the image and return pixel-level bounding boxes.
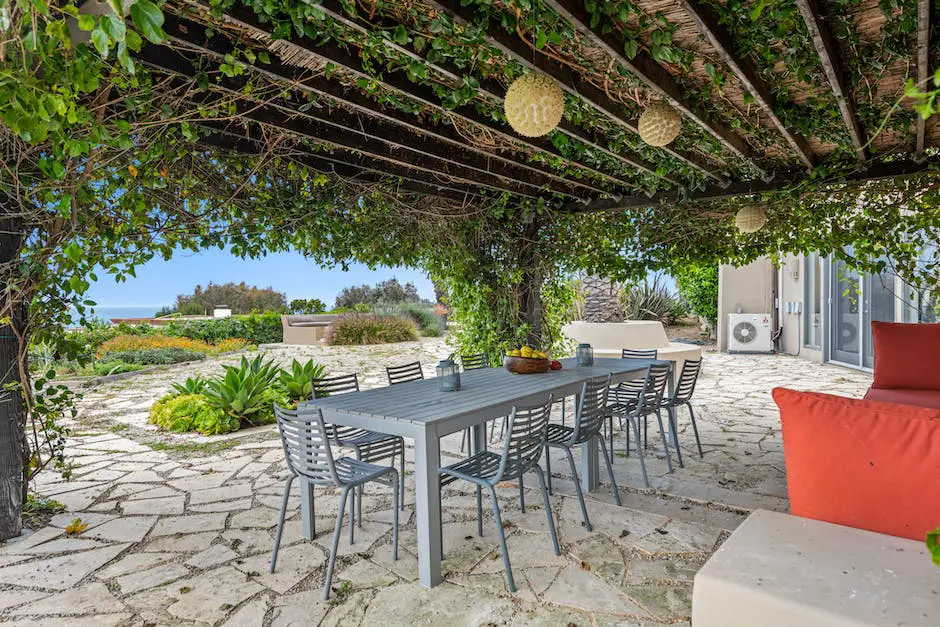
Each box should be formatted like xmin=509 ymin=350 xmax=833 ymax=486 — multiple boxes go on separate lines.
xmin=129 ymin=0 xmax=940 ymax=212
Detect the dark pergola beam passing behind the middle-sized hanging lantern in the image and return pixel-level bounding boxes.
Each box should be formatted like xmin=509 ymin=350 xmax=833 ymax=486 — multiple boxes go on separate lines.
xmin=428 ymin=0 xmax=727 ymax=184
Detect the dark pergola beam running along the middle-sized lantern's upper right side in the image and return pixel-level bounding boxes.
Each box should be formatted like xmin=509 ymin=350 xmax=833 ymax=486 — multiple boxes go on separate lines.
xmin=545 ymin=0 xmax=764 ymax=176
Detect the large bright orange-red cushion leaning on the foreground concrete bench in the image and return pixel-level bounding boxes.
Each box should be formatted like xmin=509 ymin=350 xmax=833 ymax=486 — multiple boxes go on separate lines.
xmin=773 ymin=388 xmax=940 ymax=541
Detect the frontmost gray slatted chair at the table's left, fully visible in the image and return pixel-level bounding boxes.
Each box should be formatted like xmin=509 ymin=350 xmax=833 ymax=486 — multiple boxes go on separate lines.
xmin=270 ymin=404 xmax=398 ymax=599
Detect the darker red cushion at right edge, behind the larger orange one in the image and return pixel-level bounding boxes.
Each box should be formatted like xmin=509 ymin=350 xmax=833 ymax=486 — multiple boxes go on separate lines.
xmin=871 ymin=322 xmax=940 ymax=390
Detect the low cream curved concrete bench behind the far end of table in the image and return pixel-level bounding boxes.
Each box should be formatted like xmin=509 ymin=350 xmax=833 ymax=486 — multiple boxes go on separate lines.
xmin=562 ymin=320 xmax=702 ymax=376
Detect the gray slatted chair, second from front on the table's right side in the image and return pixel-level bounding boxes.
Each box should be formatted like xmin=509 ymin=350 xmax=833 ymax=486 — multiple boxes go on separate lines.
xmin=545 ymin=375 xmax=621 ymax=531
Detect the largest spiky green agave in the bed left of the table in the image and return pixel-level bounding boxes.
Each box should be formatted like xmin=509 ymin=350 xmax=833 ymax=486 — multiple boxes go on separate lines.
xmin=204 ymin=355 xmax=279 ymax=424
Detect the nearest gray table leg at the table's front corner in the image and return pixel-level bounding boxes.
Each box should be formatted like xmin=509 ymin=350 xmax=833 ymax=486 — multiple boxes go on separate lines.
xmin=415 ymin=430 xmax=440 ymax=588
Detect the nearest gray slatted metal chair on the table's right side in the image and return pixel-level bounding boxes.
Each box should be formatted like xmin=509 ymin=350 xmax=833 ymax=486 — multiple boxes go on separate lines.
xmin=440 ymin=395 xmax=561 ymax=592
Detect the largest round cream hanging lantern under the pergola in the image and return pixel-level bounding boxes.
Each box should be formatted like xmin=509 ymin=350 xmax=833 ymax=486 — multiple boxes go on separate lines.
xmin=503 ymin=74 xmax=565 ymax=137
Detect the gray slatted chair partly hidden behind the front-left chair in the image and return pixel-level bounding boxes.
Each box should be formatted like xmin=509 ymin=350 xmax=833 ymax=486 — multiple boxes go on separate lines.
xmin=311 ymin=373 xmax=405 ymax=527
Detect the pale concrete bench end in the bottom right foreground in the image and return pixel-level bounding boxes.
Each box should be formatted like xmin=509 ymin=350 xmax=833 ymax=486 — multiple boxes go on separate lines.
xmin=692 ymin=510 xmax=940 ymax=627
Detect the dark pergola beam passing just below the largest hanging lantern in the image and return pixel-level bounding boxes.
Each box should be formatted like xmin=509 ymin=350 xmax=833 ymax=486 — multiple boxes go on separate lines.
xmin=188 ymin=5 xmax=634 ymax=189
